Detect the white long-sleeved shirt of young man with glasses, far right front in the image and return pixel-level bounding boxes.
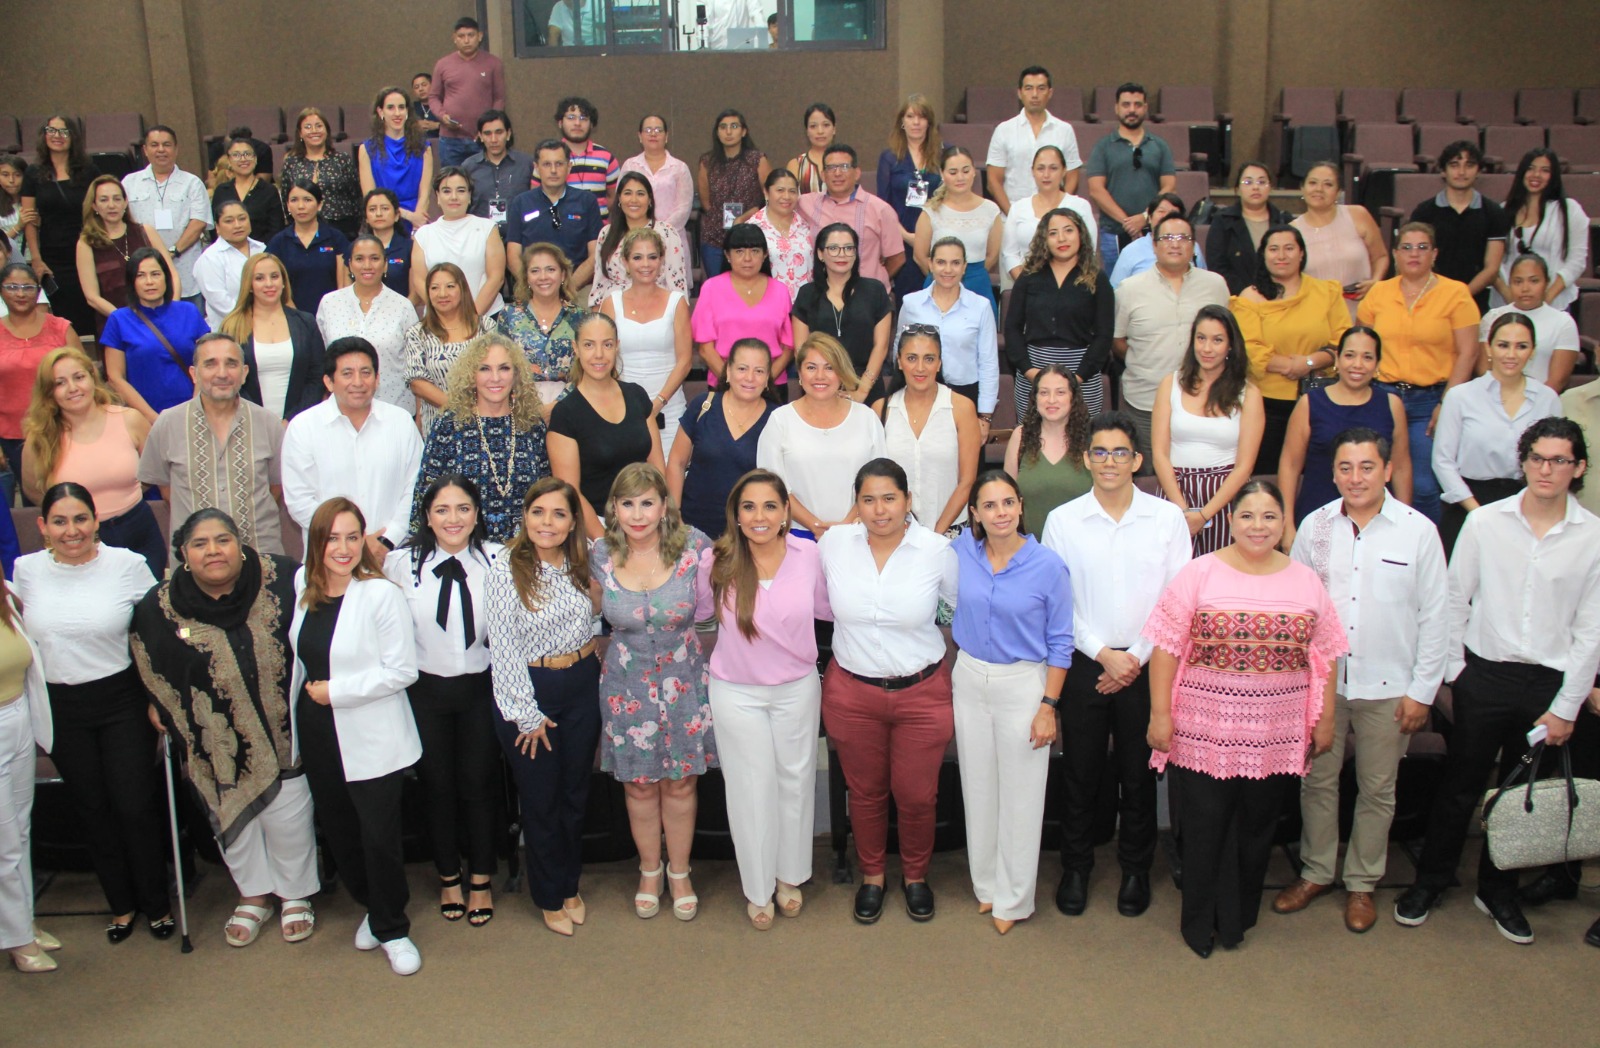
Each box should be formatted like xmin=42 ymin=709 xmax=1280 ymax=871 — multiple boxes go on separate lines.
xmin=1452 ymin=493 xmax=1600 ymax=720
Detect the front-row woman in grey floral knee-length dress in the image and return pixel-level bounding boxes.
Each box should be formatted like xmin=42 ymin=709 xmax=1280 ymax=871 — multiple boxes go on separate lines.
xmin=589 ymin=462 xmax=717 ymax=920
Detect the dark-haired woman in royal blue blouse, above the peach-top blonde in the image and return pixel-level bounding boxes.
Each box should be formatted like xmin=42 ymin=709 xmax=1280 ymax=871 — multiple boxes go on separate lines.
xmin=101 ymin=248 xmax=211 ymax=422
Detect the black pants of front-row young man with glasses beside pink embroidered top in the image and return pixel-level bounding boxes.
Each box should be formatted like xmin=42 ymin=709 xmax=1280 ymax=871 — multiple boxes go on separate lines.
xmin=1061 ymin=651 xmax=1157 ymax=874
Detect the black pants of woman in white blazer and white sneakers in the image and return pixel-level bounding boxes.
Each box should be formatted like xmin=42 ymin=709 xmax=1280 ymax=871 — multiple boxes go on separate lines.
xmin=296 ymin=690 xmax=411 ymax=942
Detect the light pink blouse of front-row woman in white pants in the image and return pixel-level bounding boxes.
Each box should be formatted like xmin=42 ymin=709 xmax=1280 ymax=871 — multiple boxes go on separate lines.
xmin=694 ymin=534 xmax=834 ymax=685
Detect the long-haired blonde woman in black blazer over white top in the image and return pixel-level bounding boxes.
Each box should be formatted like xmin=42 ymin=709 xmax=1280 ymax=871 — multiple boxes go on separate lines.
xmin=218 ymin=253 xmax=326 ymax=422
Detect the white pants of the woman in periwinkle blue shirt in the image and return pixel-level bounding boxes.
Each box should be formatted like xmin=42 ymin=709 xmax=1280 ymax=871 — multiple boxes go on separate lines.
xmin=950 ymin=651 xmax=1050 ymax=920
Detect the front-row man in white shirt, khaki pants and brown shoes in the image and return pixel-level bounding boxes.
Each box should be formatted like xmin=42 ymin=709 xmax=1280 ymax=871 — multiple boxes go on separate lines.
xmin=1272 ymin=429 xmax=1450 ymax=933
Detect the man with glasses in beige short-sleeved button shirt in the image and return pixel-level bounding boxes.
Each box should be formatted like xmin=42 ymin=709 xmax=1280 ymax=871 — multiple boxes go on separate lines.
xmin=1112 ymin=214 xmax=1229 ymax=472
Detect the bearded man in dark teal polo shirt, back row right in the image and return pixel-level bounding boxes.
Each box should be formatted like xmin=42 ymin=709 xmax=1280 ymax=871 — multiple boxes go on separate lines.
xmin=1088 ymin=83 xmax=1178 ymax=270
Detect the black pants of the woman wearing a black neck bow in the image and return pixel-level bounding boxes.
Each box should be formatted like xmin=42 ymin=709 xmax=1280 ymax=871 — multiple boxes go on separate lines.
xmin=408 ymin=670 xmax=499 ymax=877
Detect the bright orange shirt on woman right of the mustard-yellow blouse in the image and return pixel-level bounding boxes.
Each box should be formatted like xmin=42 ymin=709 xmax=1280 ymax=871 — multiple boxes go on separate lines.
xmin=1355 ymin=274 xmax=1480 ymax=386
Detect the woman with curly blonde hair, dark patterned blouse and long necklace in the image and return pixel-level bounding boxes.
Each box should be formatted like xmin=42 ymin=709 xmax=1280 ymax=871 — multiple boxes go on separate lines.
xmin=413 ymin=331 xmax=550 ymax=542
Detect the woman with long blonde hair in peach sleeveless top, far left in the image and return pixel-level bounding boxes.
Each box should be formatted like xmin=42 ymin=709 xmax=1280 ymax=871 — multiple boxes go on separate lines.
xmin=22 ymin=346 xmax=166 ymax=578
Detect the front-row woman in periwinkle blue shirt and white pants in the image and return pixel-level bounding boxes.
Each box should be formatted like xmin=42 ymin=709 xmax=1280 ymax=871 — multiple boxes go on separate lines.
xmin=950 ymin=469 xmax=1072 ymax=934
